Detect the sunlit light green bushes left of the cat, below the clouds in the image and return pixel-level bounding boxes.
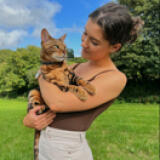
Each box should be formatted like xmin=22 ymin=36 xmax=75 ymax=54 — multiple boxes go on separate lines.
xmin=0 ymin=46 xmax=40 ymax=94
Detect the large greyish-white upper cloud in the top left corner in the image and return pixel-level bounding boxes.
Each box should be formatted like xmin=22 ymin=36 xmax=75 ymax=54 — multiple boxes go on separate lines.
xmin=0 ymin=0 xmax=61 ymax=29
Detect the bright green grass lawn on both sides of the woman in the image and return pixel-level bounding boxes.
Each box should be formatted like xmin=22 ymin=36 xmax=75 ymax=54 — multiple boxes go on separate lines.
xmin=0 ymin=99 xmax=159 ymax=160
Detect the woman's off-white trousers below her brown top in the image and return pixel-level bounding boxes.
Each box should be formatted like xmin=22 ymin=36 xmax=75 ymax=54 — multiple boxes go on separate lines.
xmin=39 ymin=127 xmax=93 ymax=160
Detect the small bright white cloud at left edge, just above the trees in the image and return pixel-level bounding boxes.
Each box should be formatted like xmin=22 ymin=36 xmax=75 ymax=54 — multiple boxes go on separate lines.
xmin=0 ymin=30 xmax=27 ymax=49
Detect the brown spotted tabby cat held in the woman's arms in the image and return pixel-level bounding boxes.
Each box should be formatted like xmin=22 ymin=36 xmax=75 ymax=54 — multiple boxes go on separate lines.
xmin=28 ymin=29 xmax=95 ymax=160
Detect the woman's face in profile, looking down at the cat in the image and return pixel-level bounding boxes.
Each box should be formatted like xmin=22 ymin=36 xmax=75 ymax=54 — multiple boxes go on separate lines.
xmin=81 ymin=19 xmax=112 ymax=60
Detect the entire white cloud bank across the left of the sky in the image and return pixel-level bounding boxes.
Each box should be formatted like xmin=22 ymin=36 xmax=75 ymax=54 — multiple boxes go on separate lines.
xmin=0 ymin=0 xmax=82 ymax=49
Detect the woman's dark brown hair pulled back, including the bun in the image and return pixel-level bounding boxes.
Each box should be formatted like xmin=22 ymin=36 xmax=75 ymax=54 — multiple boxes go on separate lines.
xmin=89 ymin=2 xmax=144 ymax=45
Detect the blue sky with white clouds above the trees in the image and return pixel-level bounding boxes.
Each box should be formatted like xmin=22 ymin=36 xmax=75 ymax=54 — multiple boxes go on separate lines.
xmin=0 ymin=0 xmax=111 ymax=57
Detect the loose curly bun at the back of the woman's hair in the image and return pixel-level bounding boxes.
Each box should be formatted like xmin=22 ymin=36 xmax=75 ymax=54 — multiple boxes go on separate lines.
xmin=128 ymin=17 xmax=144 ymax=43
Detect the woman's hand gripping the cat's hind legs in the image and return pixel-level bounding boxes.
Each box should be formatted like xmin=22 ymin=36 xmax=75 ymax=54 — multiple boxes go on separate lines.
xmin=23 ymin=106 xmax=56 ymax=130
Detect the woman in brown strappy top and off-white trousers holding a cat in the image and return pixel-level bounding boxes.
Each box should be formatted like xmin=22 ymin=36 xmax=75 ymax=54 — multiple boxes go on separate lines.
xmin=23 ymin=3 xmax=143 ymax=160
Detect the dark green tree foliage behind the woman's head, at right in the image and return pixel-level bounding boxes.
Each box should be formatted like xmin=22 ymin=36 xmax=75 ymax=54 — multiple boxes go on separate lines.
xmin=112 ymin=0 xmax=160 ymax=80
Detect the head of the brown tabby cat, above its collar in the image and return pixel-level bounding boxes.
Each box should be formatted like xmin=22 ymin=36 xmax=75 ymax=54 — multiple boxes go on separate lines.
xmin=41 ymin=29 xmax=67 ymax=62
